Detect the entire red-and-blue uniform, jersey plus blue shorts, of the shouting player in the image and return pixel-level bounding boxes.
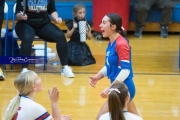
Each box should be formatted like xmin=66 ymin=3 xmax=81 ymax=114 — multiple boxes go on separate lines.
xmin=105 ymin=35 xmax=135 ymax=99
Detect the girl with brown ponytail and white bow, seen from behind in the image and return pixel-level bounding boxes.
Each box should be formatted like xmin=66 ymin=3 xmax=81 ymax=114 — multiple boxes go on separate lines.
xmin=99 ymin=83 xmax=143 ymax=120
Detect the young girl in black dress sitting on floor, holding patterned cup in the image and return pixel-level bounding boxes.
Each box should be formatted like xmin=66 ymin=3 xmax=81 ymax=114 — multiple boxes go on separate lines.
xmin=65 ymin=4 xmax=96 ymax=66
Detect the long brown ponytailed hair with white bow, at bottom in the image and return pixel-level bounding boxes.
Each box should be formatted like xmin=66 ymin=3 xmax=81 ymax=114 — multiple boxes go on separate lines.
xmin=108 ymin=83 xmax=128 ymax=120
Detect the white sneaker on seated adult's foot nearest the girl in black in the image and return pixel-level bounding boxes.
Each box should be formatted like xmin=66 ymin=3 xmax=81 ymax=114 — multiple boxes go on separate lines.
xmin=61 ymin=66 xmax=75 ymax=77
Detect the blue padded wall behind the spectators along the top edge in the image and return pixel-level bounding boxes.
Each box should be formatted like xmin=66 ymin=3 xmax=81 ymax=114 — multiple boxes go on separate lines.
xmin=7 ymin=0 xmax=180 ymax=22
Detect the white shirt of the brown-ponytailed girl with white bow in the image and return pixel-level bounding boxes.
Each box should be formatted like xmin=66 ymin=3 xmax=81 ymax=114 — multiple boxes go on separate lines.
xmin=99 ymin=112 xmax=143 ymax=120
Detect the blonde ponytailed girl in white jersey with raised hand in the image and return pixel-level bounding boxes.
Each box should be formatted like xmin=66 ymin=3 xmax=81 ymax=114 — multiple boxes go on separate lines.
xmin=5 ymin=70 xmax=71 ymax=120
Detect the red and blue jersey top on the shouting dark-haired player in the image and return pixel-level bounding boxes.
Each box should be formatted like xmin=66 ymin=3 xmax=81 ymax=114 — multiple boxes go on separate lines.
xmin=105 ymin=35 xmax=133 ymax=83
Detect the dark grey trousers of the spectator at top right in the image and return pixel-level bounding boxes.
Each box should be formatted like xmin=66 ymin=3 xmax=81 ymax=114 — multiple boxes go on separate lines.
xmin=134 ymin=0 xmax=174 ymax=27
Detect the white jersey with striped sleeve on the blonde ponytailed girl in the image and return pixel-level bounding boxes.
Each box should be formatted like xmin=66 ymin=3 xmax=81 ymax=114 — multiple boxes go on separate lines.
xmin=6 ymin=96 xmax=52 ymax=120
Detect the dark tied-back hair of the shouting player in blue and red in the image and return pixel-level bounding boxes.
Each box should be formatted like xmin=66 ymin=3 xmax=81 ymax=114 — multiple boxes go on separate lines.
xmin=106 ymin=13 xmax=126 ymax=37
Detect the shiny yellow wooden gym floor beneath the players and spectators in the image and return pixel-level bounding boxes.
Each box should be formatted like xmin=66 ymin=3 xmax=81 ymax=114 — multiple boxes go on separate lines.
xmin=0 ymin=33 xmax=180 ymax=120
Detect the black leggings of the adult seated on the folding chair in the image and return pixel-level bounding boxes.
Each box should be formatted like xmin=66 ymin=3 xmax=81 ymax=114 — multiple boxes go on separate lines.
xmin=15 ymin=21 xmax=68 ymax=68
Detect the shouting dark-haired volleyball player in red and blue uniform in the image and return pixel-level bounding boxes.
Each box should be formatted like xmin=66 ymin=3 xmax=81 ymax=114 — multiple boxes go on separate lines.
xmin=90 ymin=13 xmax=138 ymax=120
